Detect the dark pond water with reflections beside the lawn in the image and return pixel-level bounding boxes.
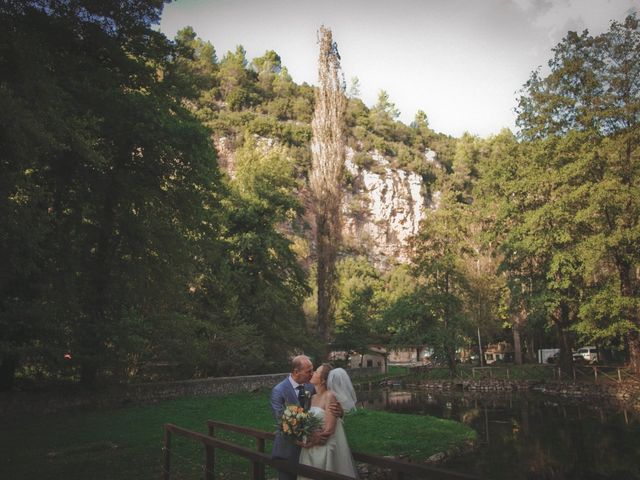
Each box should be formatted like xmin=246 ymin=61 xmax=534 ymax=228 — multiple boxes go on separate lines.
xmin=358 ymin=386 xmax=640 ymax=480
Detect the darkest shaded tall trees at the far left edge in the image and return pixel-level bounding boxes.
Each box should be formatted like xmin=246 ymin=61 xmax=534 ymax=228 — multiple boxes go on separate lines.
xmin=0 ymin=2 xmax=228 ymax=383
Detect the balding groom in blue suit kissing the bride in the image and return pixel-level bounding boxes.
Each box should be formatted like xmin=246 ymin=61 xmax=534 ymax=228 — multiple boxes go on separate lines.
xmin=271 ymin=355 xmax=344 ymax=480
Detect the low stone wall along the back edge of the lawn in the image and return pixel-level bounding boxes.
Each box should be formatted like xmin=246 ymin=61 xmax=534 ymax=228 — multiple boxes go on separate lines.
xmin=0 ymin=368 xmax=380 ymax=419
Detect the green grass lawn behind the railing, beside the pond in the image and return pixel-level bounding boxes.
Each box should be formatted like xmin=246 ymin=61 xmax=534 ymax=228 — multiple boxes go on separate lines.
xmin=0 ymin=391 xmax=475 ymax=480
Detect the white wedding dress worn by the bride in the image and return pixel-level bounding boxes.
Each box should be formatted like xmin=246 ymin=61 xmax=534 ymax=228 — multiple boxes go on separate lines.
xmin=298 ymin=407 xmax=358 ymax=480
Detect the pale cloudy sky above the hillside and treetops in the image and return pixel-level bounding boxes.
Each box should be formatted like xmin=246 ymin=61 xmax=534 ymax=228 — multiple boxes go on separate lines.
xmin=159 ymin=0 xmax=640 ymax=137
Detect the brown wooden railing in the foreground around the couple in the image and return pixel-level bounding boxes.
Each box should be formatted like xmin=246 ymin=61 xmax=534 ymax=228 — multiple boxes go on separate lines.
xmin=163 ymin=420 xmax=478 ymax=480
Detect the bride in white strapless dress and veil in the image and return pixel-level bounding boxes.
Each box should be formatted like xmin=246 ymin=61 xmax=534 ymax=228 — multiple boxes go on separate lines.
xmin=298 ymin=363 xmax=357 ymax=480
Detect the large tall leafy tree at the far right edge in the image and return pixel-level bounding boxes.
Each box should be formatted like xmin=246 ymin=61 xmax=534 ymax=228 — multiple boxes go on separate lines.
xmin=501 ymin=16 xmax=640 ymax=371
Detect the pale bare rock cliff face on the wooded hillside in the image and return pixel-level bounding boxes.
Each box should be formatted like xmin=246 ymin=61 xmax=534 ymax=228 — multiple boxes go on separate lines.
xmin=215 ymin=138 xmax=438 ymax=268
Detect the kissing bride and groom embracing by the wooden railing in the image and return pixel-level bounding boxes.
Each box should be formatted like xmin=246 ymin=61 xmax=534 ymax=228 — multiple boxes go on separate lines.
xmin=271 ymin=355 xmax=357 ymax=480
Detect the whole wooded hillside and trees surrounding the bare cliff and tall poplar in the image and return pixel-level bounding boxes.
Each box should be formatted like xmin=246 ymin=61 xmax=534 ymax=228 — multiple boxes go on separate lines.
xmin=0 ymin=0 xmax=640 ymax=389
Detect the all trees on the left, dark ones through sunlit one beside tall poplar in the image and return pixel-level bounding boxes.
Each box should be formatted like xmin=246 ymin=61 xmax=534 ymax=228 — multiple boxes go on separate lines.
xmin=0 ymin=1 xmax=307 ymax=388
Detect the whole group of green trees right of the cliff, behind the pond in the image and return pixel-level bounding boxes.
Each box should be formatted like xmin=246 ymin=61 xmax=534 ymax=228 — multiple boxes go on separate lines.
xmin=380 ymin=16 xmax=640 ymax=371
